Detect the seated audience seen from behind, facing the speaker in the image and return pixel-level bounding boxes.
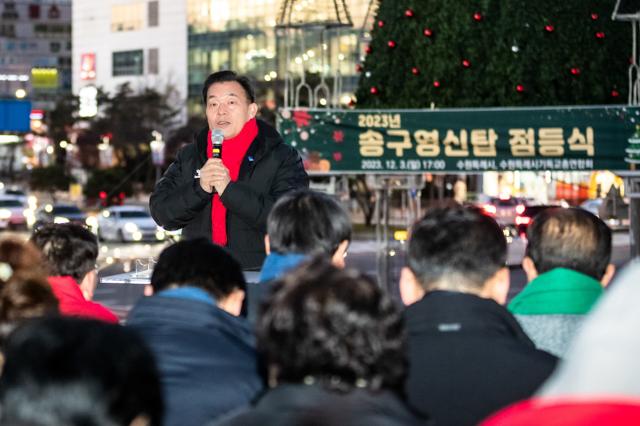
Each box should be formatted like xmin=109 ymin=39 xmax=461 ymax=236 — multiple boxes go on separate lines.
xmin=0 ymin=189 xmax=640 ymax=426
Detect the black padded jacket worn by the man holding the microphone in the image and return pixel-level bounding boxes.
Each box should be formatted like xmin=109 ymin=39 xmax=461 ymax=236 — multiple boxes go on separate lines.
xmin=149 ymin=120 xmax=309 ymax=269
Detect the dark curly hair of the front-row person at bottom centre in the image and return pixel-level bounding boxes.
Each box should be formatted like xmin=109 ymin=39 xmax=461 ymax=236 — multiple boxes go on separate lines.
xmin=257 ymin=258 xmax=406 ymax=390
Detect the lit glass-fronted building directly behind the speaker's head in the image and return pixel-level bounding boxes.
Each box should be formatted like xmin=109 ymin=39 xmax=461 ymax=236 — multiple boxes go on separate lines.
xmin=188 ymin=0 xmax=378 ymax=113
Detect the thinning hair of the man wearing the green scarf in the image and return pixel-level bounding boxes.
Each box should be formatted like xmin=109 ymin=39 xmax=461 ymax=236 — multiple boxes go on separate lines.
xmin=526 ymin=208 xmax=611 ymax=280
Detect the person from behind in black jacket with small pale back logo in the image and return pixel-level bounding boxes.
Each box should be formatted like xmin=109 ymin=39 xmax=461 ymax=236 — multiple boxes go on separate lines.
xmin=400 ymin=206 xmax=556 ymax=426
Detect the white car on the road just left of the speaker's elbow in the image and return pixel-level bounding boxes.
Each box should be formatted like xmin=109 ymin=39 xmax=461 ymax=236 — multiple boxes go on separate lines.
xmin=98 ymin=206 xmax=166 ymax=242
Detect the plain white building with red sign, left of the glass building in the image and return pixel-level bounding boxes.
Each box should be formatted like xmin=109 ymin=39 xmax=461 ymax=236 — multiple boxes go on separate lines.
xmin=73 ymin=0 xmax=187 ymax=121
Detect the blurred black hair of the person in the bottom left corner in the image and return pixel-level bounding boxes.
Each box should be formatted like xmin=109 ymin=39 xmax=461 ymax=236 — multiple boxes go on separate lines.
xmin=0 ymin=317 xmax=163 ymax=426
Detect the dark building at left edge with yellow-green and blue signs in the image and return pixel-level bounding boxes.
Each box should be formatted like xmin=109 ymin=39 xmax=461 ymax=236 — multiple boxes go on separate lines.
xmin=0 ymin=0 xmax=72 ymax=176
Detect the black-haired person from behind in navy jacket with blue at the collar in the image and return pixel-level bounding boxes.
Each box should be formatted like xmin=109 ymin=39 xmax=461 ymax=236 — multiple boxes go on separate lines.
xmin=127 ymin=238 xmax=263 ymax=426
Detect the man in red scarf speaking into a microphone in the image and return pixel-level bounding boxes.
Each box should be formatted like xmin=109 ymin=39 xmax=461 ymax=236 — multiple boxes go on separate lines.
xmin=149 ymin=71 xmax=309 ymax=269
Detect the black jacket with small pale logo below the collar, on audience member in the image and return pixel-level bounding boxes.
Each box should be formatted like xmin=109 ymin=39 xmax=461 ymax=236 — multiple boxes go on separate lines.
xmin=405 ymin=290 xmax=557 ymax=426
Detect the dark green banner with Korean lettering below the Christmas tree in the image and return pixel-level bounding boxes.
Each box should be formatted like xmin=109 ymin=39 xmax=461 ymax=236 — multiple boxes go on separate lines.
xmin=278 ymin=105 xmax=640 ymax=173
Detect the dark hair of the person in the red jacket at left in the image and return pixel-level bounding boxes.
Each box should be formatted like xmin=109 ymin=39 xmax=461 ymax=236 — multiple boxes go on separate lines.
xmin=31 ymin=223 xmax=98 ymax=282
